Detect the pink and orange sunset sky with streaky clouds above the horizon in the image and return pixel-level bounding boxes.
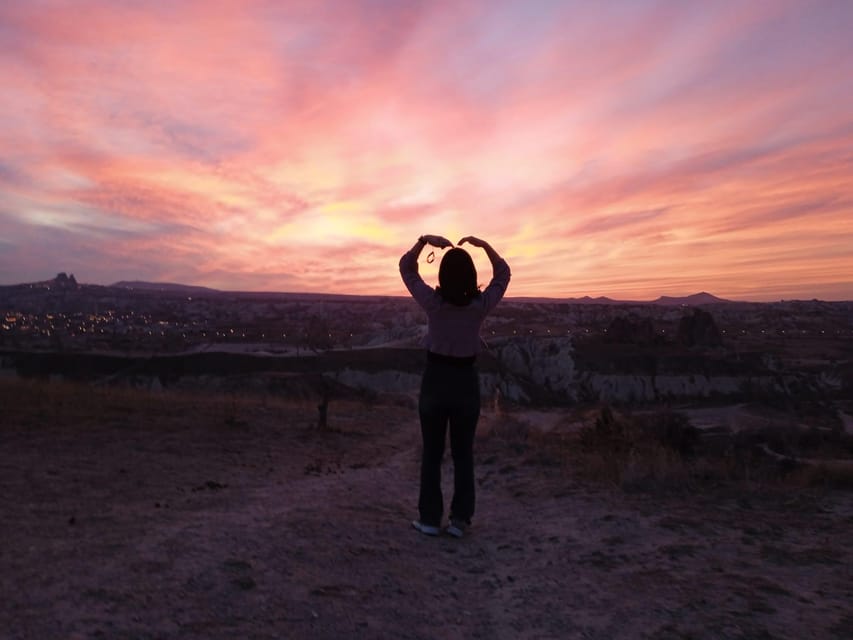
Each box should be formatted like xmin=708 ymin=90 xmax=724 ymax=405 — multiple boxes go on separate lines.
xmin=0 ymin=0 xmax=853 ymax=300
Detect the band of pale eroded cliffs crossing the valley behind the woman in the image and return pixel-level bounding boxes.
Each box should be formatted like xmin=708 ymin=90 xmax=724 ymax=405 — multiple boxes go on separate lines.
xmin=5 ymin=336 xmax=853 ymax=408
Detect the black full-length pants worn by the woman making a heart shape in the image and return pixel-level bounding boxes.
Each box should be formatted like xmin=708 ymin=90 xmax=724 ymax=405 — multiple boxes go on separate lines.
xmin=418 ymin=361 xmax=480 ymax=526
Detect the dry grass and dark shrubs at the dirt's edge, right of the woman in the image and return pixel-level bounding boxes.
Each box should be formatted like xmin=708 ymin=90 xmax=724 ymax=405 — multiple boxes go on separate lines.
xmin=482 ymin=406 xmax=853 ymax=492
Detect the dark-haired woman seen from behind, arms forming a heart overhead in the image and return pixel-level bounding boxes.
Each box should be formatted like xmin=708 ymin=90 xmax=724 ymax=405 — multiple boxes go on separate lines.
xmin=400 ymin=235 xmax=511 ymax=538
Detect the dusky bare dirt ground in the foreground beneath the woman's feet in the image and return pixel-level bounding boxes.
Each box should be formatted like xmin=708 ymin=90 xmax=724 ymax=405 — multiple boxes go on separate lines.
xmin=0 ymin=382 xmax=853 ymax=640
